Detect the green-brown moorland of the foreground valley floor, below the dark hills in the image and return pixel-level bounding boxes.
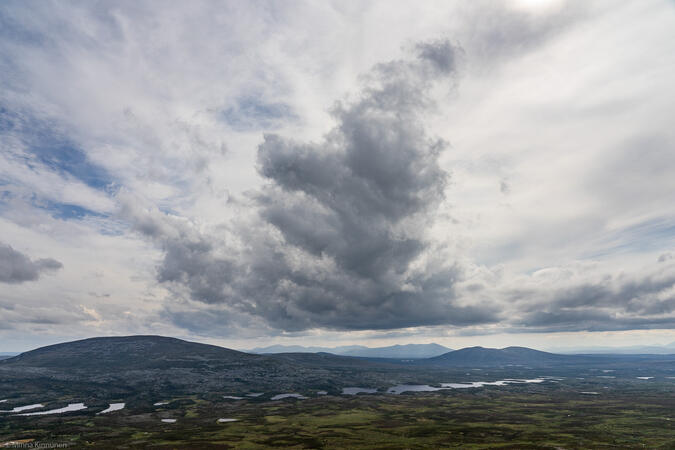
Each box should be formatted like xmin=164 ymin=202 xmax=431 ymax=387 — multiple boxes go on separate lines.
xmin=0 ymin=380 xmax=675 ymax=449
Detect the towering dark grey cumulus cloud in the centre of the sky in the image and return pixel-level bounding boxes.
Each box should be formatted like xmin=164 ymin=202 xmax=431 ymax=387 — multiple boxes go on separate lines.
xmin=127 ymin=41 xmax=495 ymax=330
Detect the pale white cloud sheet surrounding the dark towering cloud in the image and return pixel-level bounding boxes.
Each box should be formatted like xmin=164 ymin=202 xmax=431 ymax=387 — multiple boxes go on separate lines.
xmin=0 ymin=1 xmax=675 ymax=350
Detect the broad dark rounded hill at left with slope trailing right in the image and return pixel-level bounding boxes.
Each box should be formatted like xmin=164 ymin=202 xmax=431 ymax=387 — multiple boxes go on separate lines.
xmin=0 ymin=336 xmax=390 ymax=396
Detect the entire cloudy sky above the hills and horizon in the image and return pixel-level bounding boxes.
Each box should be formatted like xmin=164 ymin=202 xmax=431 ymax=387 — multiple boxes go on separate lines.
xmin=0 ymin=0 xmax=675 ymax=351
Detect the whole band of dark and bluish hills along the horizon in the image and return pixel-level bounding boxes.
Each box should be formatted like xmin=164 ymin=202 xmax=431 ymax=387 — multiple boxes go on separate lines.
xmin=0 ymin=336 xmax=675 ymax=401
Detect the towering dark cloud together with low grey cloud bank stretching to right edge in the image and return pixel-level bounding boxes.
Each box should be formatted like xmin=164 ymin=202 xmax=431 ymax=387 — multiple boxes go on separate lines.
xmin=118 ymin=35 xmax=675 ymax=335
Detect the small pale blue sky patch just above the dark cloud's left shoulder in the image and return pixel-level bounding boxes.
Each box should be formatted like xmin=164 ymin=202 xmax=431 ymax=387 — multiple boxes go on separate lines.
xmin=221 ymin=95 xmax=298 ymax=131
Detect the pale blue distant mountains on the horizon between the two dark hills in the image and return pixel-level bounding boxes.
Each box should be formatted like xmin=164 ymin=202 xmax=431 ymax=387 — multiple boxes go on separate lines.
xmin=248 ymin=343 xmax=452 ymax=359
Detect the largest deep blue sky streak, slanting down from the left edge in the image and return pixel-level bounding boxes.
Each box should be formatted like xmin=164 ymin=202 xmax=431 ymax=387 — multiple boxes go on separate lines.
xmin=0 ymin=105 xmax=115 ymax=192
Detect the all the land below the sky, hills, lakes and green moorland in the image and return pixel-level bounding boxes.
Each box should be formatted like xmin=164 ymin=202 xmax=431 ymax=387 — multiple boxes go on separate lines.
xmin=0 ymin=337 xmax=675 ymax=449
